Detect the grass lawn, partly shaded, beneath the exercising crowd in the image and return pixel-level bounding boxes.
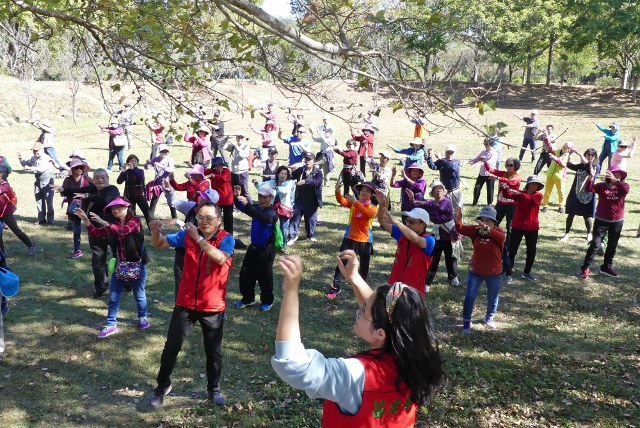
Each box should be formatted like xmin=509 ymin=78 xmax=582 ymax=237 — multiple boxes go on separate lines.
xmin=0 ymin=94 xmax=640 ymax=427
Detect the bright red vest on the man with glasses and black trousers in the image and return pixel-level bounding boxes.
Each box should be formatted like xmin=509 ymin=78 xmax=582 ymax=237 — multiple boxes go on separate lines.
xmin=176 ymin=229 xmax=233 ymax=312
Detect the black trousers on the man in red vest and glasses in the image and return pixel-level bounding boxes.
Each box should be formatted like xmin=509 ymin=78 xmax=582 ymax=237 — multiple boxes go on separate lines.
xmin=156 ymin=306 xmax=224 ymax=394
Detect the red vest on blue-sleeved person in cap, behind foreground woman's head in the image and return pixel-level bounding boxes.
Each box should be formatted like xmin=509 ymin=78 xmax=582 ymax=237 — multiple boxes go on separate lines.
xmin=387 ymin=234 xmax=431 ymax=296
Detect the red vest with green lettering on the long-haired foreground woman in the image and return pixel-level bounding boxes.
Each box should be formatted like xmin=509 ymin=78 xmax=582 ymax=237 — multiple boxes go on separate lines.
xmin=322 ymin=352 xmax=424 ymax=428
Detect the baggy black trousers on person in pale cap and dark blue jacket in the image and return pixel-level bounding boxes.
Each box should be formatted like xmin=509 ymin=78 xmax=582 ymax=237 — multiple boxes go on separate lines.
xmin=239 ymin=244 xmax=276 ymax=305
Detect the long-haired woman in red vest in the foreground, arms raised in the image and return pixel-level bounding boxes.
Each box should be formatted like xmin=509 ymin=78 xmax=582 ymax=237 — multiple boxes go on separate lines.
xmin=271 ymin=250 xmax=444 ymax=427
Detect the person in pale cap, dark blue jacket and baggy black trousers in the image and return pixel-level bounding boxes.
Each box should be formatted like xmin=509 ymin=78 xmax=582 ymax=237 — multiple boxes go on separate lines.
xmin=233 ymin=185 xmax=279 ymax=312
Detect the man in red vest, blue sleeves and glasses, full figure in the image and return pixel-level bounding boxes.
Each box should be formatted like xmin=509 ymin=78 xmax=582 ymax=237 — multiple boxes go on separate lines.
xmin=150 ymin=202 xmax=235 ymax=408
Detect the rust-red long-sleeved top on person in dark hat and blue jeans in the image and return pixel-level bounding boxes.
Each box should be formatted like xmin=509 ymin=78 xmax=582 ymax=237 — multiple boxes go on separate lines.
xmin=456 ymin=222 xmax=505 ymax=276
